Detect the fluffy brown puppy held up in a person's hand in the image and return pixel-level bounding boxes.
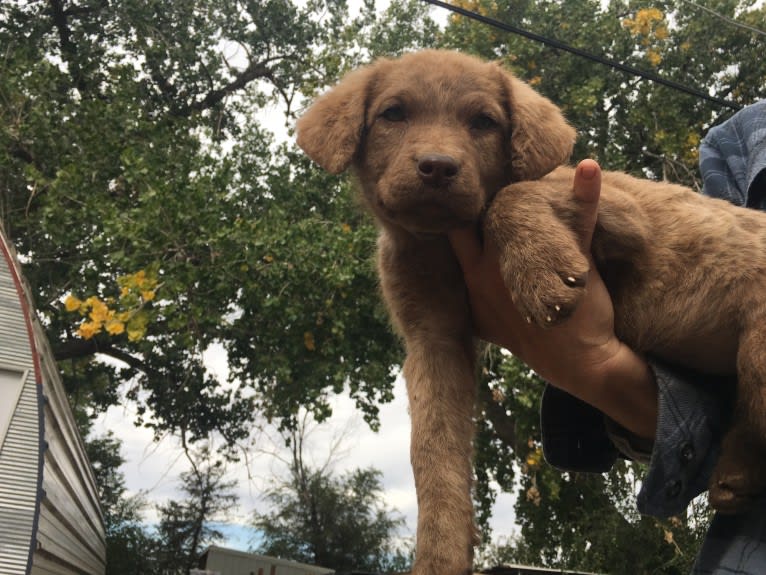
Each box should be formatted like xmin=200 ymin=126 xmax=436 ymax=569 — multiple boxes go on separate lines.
xmin=297 ymin=51 xmax=766 ymax=575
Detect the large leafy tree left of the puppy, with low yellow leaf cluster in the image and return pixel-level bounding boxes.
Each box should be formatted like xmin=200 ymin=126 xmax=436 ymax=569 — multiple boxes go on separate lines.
xmin=0 ymin=0 xmax=433 ymax=454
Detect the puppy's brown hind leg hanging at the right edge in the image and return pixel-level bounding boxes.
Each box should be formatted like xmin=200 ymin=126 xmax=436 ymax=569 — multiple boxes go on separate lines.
xmin=709 ymin=322 xmax=766 ymax=514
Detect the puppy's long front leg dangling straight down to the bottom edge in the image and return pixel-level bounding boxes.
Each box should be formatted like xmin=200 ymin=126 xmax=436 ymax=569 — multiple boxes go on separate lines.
xmin=379 ymin=234 xmax=476 ymax=575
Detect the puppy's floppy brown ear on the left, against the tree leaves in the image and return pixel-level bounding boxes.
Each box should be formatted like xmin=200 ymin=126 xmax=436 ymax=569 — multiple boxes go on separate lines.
xmin=296 ymin=64 xmax=378 ymax=174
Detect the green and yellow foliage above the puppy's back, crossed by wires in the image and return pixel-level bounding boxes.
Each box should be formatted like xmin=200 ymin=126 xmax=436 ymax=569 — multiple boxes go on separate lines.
xmin=444 ymin=0 xmax=766 ymax=185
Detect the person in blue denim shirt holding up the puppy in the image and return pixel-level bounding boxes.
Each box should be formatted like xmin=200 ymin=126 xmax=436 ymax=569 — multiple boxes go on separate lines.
xmin=450 ymin=100 xmax=766 ymax=575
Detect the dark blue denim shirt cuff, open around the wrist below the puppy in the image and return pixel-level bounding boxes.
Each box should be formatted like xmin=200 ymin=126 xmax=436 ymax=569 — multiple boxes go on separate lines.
xmin=540 ymin=361 xmax=735 ymax=517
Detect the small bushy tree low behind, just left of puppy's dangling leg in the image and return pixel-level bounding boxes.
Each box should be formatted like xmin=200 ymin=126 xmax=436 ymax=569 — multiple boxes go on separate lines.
xmin=253 ymin=417 xmax=411 ymax=572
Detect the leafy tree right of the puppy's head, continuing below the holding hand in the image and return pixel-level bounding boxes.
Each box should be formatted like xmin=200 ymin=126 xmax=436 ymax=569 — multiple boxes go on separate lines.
xmin=444 ymin=0 xmax=766 ymax=573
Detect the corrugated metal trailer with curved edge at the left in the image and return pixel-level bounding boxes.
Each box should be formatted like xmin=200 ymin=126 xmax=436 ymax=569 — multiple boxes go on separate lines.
xmin=0 ymin=230 xmax=106 ymax=575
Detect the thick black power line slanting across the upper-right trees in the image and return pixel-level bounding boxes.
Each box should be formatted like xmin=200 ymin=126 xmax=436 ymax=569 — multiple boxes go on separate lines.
xmin=423 ymin=0 xmax=742 ymax=110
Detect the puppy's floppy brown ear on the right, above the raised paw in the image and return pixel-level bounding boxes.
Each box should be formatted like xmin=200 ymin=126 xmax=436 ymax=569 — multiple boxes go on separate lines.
xmin=503 ymin=70 xmax=577 ymax=181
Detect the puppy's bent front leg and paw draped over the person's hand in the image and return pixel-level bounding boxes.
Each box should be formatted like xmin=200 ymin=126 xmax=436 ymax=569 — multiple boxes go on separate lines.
xmin=484 ymin=181 xmax=589 ymax=327
